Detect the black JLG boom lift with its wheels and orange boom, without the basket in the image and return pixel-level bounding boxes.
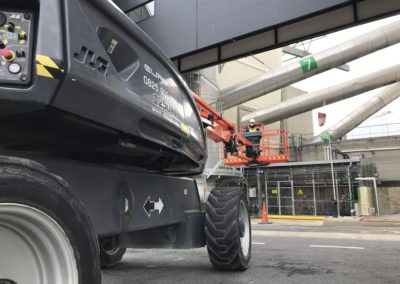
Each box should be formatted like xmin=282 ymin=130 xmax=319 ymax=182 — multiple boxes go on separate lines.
xmin=0 ymin=0 xmax=288 ymax=284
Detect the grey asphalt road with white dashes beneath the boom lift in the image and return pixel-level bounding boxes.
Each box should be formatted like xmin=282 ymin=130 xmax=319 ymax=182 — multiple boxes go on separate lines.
xmin=103 ymin=225 xmax=400 ymax=284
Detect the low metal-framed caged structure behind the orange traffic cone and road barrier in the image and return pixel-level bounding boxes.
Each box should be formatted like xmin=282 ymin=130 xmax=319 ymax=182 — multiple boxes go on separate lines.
xmin=246 ymin=159 xmax=370 ymax=216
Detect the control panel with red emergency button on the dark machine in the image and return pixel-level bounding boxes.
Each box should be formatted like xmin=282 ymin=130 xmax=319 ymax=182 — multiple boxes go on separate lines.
xmin=0 ymin=10 xmax=33 ymax=85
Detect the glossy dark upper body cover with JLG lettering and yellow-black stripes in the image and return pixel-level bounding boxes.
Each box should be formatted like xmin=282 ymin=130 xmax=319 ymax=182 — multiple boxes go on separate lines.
xmin=0 ymin=0 xmax=207 ymax=175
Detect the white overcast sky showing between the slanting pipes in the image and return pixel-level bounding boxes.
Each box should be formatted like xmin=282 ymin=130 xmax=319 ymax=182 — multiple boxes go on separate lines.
xmin=283 ymin=13 xmax=400 ymax=134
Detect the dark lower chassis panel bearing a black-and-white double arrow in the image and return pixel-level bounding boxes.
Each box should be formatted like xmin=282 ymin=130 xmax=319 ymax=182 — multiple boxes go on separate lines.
xmin=0 ymin=149 xmax=205 ymax=248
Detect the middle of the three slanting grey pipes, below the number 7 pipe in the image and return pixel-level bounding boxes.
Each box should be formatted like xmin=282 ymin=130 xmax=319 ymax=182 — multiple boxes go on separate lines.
xmin=242 ymin=64 xmax=400 ymax=123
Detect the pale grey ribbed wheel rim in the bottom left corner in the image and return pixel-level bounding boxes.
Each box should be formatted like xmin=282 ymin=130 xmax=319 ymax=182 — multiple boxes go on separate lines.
xmin=0 ymin=203 xmax=79 ymax=284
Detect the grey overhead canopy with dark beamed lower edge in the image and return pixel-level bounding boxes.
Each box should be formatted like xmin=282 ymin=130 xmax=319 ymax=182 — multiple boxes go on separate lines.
xmin=129 ymin=0 xmax=400 ymax=72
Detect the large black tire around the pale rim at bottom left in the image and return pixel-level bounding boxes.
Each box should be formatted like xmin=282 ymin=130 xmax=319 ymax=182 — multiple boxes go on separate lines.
xmin=0 ymin=157 xmax=101 ymax=284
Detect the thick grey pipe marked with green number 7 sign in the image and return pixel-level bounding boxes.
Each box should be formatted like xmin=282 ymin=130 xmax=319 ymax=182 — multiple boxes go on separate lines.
xmin=220 ymin=18 xmax=400 ymax=110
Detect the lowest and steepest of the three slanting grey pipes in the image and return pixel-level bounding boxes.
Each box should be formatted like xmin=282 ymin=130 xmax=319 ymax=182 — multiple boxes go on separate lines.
xmin=313 ymin=83 xmax=400 ymax=142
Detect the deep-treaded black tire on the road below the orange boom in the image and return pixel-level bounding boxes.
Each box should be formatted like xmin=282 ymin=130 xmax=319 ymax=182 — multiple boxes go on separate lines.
xmin=206 ymin=188 xmax=251 ymax=271
